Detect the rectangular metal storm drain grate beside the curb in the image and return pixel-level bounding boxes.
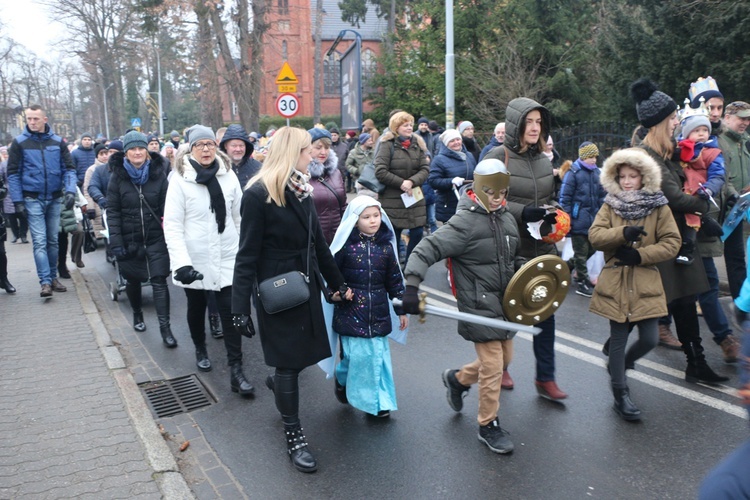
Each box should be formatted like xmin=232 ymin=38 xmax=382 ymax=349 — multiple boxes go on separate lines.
xmin=140 ymin=375 xmax=216 ymax=418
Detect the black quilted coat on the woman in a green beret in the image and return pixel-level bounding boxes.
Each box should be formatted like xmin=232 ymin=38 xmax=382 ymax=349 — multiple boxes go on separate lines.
xmin=107 ymin=151 xmax=169 ymax=282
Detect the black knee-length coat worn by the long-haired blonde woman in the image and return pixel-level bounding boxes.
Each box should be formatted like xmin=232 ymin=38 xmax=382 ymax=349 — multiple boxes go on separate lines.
xmin=232 ymin=182 xmax=344 ymax=369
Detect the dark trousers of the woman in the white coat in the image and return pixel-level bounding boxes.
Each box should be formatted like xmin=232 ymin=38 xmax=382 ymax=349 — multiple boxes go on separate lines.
xmin=185 ymin=286 xmax=242 ymax=366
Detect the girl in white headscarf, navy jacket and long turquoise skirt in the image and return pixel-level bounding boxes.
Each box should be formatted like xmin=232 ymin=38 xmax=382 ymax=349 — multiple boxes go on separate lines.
xmin=324 ymin=196 xmax=409 ymax=417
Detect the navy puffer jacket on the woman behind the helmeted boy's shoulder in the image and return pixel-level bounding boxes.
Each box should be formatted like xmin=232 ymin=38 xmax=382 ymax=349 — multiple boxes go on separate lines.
xmin=427 ymin=143 xmax=477 ymax=222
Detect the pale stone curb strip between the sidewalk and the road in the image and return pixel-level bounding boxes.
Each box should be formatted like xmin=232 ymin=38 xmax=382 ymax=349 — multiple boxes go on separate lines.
xmin=71 ymin=273 xmax=195 ymax=499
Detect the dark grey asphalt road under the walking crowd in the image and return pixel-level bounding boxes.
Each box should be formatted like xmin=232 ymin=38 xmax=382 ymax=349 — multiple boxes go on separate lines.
xmin=86 ymin=248 xmax=748 ymax=499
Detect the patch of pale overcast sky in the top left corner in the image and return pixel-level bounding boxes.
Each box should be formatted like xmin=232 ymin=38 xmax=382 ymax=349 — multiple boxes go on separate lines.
xmin=0 ymin=0 xmax=64 ymax=59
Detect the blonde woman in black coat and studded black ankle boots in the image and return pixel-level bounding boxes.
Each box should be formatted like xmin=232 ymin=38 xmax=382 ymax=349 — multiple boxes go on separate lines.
xmin=232 ymin=127 xmax=351 ymax=472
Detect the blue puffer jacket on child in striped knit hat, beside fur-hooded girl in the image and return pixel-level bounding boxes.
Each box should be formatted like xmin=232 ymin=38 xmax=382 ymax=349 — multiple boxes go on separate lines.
xmin=560 ymin=158 xmax=607 ymax=235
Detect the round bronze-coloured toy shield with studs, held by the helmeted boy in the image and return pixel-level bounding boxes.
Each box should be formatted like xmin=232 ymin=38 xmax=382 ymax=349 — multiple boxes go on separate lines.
xmin=503 ymin=255 xmax=570 ymax=325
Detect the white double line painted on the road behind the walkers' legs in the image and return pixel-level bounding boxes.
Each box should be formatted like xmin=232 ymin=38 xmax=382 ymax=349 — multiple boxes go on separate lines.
xmin=420 ymin=285 xmax=747 ymax=419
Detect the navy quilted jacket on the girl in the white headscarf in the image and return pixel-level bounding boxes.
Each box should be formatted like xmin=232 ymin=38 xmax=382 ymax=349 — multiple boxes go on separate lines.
xmin=333 ymin=228 xmax=404 ymax=338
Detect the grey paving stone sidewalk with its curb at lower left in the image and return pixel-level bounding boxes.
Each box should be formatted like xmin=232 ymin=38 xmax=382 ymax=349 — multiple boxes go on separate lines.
xmin=0 ymin=242 xmax=193 ymax=499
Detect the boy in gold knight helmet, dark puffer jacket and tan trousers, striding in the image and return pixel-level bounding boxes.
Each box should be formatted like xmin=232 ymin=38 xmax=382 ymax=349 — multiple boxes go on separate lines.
xmin=403 ymin=159 xmax=524 ymax=453
